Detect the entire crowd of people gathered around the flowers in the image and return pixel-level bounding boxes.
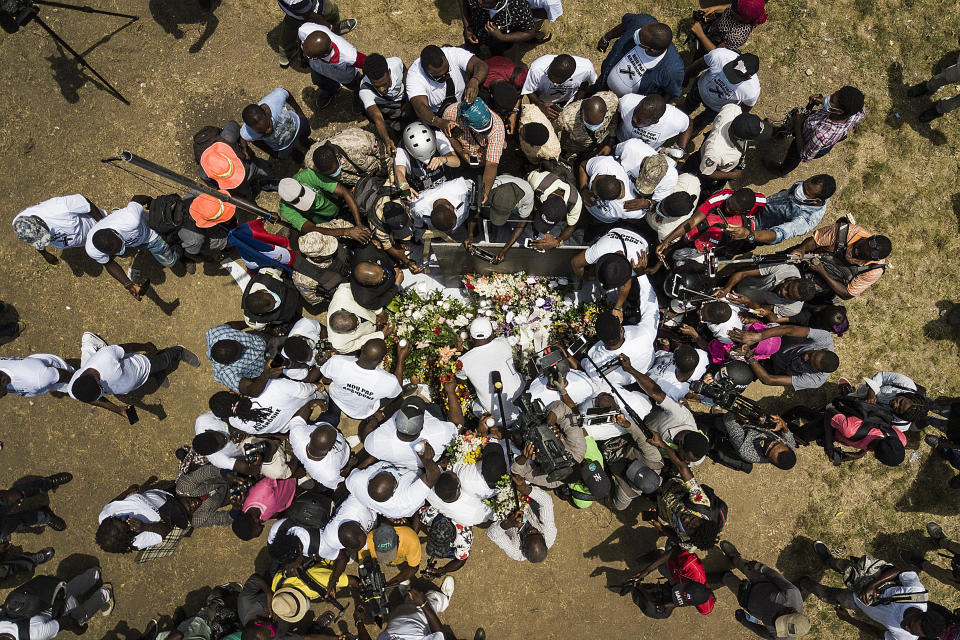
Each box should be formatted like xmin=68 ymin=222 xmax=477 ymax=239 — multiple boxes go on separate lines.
xmin=0 ymin=0 xmax=960 ymax=640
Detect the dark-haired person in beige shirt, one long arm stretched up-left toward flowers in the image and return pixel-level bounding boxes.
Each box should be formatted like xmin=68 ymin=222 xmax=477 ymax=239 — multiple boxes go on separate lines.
xmin=620 ymin=355 xmax=710 ymax=465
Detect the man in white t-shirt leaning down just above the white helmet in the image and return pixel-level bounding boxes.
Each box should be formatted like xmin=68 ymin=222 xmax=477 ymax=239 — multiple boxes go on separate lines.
xmin=406 ymin=44 xmax=490 ymax=138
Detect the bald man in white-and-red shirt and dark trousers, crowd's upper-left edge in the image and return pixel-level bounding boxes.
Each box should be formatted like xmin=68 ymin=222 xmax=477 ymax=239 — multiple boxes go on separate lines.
xmin=297 ymin=22 xmax=365 ymax=109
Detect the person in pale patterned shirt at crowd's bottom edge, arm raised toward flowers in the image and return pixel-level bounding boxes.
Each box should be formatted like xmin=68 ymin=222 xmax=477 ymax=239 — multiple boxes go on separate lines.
xmin=487 ymin=475 xmax=557 ymax=563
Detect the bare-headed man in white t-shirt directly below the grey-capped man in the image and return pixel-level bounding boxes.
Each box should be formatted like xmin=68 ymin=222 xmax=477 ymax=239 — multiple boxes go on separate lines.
xmin=347 ymin=443 xmax=440 ymax=518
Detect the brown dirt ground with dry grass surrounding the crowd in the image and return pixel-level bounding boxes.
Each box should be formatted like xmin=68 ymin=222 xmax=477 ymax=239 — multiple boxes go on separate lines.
xmin=0 ymin=0 xmax=960 ymax=640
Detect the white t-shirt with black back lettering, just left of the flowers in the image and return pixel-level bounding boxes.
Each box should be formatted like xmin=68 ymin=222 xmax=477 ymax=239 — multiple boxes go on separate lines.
xmin=320 ymin=356 xmax=402 ymax=420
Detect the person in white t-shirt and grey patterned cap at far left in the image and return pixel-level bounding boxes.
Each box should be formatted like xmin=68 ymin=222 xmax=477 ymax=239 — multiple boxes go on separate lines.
xmin=13 ymin=193 xmax=106 ymax=264
